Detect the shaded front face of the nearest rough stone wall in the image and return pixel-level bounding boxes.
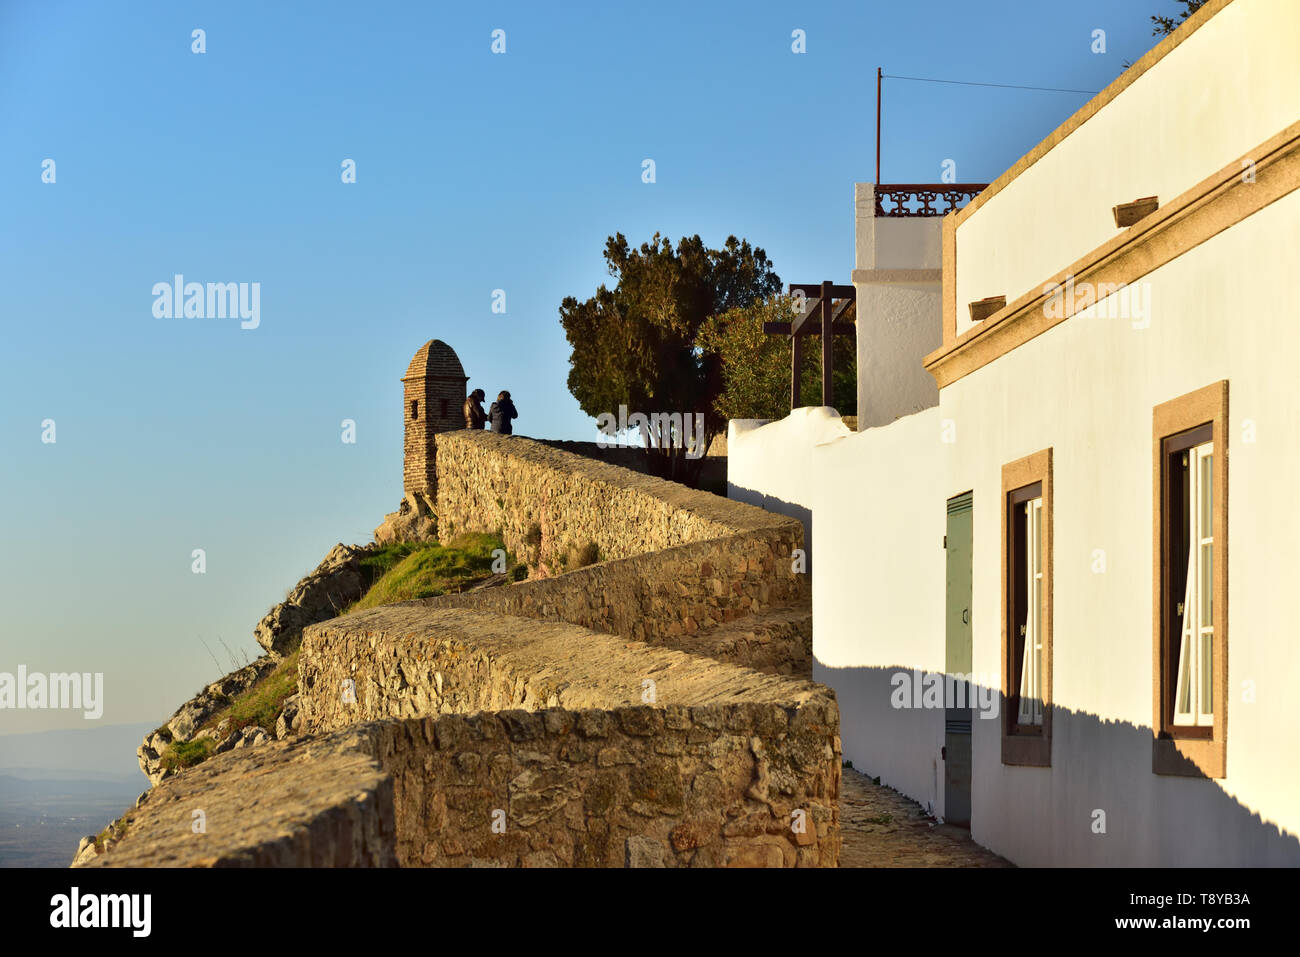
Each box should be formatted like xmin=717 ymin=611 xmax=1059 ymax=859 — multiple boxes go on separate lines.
xmin=376 ymin=700 xmax=840 ymax=867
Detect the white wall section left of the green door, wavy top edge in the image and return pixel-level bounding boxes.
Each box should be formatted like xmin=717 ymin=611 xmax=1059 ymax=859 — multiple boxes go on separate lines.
xmin=727 ymin=408 xmax=945 ymax=813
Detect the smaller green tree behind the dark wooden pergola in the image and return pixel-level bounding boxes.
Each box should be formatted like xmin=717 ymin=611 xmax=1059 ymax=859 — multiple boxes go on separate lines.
xmin=699 ymin=295 xmax=858 ymax=419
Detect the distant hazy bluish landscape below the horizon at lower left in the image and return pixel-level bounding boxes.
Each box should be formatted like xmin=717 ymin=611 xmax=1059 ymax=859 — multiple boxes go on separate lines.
xmin=0 ymin=724 xmax=152 ymax=867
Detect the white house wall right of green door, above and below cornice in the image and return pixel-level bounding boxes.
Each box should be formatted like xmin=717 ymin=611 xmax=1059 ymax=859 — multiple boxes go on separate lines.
xmin=946 ymin=0 xmax=1300 ymax=865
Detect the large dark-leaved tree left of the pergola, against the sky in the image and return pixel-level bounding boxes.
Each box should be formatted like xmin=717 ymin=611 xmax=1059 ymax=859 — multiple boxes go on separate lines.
xmin=559 ymin=233 xmax=781 ymax=484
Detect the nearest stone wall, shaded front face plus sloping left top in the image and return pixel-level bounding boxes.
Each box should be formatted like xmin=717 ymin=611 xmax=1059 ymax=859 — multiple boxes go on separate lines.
xmin=86 ymin=697 xmax=840 ymax=867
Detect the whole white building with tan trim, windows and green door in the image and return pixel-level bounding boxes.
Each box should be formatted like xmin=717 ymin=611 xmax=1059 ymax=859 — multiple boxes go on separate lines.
xmin=728 ymin=0 xmax=1300 ymax=865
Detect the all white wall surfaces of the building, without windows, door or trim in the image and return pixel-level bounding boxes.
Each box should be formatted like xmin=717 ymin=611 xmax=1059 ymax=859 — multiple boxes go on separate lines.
xmin=729 ymin=0 xmax=1300 ymax=866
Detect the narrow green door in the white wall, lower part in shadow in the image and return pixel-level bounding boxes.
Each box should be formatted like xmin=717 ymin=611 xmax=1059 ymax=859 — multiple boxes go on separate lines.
xmin=944 ymin=492 xmax=974 ymax=827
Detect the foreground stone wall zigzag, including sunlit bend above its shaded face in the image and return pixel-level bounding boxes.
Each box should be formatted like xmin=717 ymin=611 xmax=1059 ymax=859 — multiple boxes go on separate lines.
xmin=96 ymin=603 xmax=841 ymax=867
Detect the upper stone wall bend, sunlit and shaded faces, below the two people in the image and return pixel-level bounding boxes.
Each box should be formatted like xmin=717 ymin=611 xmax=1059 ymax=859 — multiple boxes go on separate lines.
xmin=424 ymin=432 xmax=813 ymax=675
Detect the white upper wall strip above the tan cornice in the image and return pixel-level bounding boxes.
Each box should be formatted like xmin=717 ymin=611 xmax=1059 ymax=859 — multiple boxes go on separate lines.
xmin=957 ymin=0 xmax=1300 ymax=333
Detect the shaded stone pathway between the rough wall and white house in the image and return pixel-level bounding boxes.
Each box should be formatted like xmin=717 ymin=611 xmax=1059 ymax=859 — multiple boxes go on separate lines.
xmin=840 ymin=767 xmax=1013 ymax=867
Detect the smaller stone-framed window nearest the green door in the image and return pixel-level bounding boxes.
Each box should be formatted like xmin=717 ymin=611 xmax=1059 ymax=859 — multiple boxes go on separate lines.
xmin=1002 ymin=449 xmax=1052 ymax=767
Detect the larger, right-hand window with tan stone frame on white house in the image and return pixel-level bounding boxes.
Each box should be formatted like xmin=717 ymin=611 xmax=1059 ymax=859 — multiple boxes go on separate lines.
xmin=1152 ymin=381 xmax=1227 ymax=778
